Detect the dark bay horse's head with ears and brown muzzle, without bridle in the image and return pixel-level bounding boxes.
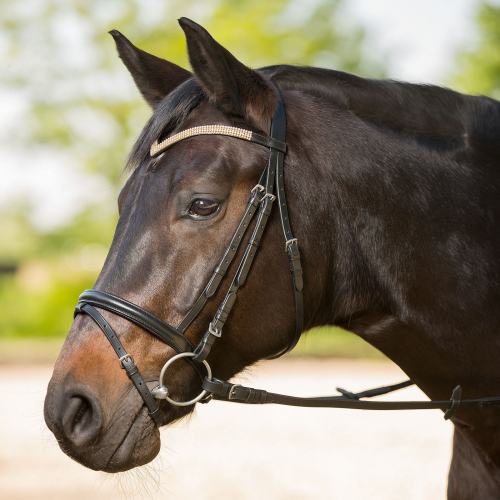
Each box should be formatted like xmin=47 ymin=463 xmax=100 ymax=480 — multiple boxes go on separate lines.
xmin=45 ymin=19 xmax=316 ymax=472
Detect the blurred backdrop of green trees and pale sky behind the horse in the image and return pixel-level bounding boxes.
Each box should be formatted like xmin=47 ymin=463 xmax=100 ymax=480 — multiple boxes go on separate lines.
xmin=0 ymin=0 xmax=500 ymax=498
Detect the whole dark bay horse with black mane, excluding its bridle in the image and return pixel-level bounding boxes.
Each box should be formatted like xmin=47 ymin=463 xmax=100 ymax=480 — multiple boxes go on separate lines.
xmin=45 ymin=19 xmax=500 ymax=499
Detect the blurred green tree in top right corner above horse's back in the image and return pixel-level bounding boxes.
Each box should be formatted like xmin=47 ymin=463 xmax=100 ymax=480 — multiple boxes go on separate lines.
xmin=452 ymin=2 xmax=500 ymax=99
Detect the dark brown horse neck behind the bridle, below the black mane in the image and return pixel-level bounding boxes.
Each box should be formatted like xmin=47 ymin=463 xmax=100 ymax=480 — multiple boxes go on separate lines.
xmin=288 ymin=87 xmax=500 ymax=464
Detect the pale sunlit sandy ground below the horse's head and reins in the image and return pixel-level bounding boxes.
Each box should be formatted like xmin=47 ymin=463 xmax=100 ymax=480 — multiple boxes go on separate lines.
xmin=0 ymin=359 xmax=452 ymax=500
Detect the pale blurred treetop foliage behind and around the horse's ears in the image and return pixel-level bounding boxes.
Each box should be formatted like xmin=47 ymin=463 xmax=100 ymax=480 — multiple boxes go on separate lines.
xmin=0 ymin=0 xmax=382 ymax=180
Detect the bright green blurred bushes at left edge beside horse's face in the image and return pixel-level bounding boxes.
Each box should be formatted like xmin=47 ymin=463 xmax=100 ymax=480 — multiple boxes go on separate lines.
xmin=0 ymin=207 xmax=116 ymax=337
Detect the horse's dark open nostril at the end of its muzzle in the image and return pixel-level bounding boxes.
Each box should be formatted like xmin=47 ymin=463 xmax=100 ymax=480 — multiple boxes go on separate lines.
xmin=61 ymin=393 xmax=102 ymax=446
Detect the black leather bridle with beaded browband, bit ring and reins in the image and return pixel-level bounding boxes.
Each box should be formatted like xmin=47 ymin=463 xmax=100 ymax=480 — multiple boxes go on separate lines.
xmin=75 ymin=93 xmax=500 ymax=427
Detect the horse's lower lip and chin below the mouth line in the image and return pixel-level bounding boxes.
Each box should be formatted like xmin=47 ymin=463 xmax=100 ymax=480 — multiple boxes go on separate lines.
xmin=101 ymin=406 xmax=161 ymax=473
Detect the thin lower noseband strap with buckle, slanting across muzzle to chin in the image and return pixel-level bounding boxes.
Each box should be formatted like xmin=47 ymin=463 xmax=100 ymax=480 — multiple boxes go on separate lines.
xmin=75 ymin=304 xmax=162 ymax=427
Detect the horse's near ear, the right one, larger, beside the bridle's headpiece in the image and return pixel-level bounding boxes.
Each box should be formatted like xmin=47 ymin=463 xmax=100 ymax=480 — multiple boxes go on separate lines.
xmin=179 ymin=17 xmax=277 ymax=131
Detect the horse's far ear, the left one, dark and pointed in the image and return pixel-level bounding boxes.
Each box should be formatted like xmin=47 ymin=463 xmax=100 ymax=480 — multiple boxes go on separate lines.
xmin=109 ymin=30 xmax=192 ymax=109
